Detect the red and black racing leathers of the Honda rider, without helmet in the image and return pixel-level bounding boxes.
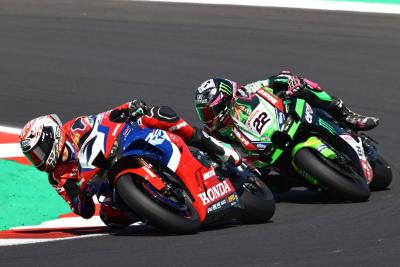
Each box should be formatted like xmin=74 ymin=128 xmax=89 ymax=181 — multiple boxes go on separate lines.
xmin=49 ymin=100 xmax=240 ymax=225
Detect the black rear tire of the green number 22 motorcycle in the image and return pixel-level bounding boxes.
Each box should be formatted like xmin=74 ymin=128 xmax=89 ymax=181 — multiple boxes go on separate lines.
xmin=369 ymin=154 xmax=392 ymax=191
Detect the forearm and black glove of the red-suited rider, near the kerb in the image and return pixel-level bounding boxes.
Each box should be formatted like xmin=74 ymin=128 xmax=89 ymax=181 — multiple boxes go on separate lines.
xmin=49 ymin=173 xmax=95 ymax=219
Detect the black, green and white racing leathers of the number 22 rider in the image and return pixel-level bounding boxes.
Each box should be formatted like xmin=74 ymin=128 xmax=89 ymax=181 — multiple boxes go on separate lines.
xmin=202 ymin=72 xmax=378 ymax=191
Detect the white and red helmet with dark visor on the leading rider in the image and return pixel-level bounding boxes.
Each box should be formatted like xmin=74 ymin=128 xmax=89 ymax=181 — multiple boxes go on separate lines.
xmin=19 ymin=114 xmax=66 ymax=172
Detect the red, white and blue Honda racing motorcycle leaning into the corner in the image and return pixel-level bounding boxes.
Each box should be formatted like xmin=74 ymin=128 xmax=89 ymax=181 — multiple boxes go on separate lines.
xmin=79 ymin=112 xmax=275 ymax=233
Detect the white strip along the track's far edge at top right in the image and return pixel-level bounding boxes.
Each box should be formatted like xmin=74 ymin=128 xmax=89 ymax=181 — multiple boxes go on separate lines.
xmin=137 ymin=0 xmax=400 ymax=14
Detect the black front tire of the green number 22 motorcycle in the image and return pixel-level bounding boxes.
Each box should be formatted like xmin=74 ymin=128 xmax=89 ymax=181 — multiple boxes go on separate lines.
xmin=294 ymin=148 xmax=371 ymax=202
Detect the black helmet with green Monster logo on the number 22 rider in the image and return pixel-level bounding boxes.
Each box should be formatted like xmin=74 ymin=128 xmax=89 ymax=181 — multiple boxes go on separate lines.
xmin=194 ymin=78 xmax=237 ymax=131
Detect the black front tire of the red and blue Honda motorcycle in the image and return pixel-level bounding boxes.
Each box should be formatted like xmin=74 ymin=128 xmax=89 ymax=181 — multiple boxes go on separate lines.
xmin=116 ymin=174 xmax=201 ymax=234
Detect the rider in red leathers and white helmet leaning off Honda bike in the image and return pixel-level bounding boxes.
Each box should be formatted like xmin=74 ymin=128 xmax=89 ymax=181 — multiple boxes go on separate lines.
xmin=19 ymin=100 xmax=241 ymax=226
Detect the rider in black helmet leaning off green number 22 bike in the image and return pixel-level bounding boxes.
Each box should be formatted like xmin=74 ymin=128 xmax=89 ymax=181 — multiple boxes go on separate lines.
xmin=195 ymin=71 xmax=379 ymax=191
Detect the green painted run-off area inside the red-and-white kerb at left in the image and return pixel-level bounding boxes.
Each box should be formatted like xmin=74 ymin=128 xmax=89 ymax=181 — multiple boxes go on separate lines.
xmin=0 ymin=160 xmax=70 ymax=230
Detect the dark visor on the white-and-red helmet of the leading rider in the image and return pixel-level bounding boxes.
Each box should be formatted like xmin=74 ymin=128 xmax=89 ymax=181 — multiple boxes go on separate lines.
xmin=25 ymin=127 xmax=55 ymax=167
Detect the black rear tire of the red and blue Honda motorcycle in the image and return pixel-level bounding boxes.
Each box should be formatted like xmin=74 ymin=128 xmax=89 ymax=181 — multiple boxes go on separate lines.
xmin=240 ymin=177 xmax=275 ymax=223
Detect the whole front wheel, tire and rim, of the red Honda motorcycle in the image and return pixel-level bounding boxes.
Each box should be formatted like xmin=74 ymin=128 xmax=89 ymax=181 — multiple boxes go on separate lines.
xmin=116 ymin=174 xmax=201 ymax=234
